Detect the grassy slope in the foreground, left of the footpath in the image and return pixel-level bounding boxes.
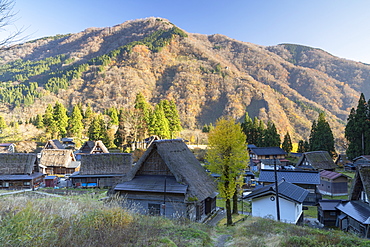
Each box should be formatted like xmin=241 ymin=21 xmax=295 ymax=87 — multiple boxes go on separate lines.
xmin=0 ymin=192 xmax=212 ymax=247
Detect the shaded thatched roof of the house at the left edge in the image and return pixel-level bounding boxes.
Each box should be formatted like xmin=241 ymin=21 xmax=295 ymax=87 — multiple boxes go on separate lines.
xmin=0 ymin=153 xmax=36 ymax=175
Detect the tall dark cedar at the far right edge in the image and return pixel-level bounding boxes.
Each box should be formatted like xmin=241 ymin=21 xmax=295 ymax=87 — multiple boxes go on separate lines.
xmin=345 ymin=93 xmax=370 ymax=159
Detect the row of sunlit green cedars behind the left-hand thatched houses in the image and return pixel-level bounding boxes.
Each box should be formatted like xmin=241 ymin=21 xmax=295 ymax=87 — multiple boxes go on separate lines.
xmin=29 ymin=93 xmax=182 ymax=150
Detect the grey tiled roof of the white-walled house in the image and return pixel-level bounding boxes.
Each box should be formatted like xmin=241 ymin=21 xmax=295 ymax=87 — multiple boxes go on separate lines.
xmin=244 ymin=181 xmax=309 ymax=203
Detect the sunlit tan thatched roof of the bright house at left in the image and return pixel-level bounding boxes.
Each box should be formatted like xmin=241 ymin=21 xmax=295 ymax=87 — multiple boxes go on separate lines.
xmin=40 ymin=149 xmax=76 ymax=168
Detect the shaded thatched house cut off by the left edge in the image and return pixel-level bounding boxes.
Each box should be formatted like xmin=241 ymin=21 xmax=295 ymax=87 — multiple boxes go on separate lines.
xmin=0 ymin=153 xmax=44 ymax=189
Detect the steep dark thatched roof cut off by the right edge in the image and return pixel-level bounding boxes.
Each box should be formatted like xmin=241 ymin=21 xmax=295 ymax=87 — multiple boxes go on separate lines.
xmin=349 ymin=165 xmax=370 ymax=200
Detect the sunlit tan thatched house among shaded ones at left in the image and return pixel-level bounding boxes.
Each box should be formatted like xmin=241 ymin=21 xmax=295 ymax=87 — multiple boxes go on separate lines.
xmin=40 ymin=149 xmax=80 ymax=175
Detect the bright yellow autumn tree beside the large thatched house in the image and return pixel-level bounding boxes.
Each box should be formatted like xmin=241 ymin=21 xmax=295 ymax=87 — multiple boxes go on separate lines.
xmin=206 ymin=118 xmax=249 ymax=225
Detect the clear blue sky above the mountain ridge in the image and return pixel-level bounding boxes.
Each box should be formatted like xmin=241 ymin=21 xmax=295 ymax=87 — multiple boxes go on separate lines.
xmin=4 ymin=0 xmax=370 ymax=63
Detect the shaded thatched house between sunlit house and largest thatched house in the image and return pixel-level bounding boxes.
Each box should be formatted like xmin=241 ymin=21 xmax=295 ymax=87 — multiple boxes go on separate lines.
xmin=70 ymin=153 xmax=132 ymax=187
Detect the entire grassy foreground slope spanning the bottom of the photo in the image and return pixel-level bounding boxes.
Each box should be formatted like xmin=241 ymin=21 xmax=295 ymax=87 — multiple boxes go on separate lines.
xmin=0 ymin=192 xmax=370 ymax=247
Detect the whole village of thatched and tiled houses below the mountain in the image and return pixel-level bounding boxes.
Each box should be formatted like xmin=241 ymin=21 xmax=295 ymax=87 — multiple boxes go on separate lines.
xmin=0 ymin=138 xmax=370 ymax=238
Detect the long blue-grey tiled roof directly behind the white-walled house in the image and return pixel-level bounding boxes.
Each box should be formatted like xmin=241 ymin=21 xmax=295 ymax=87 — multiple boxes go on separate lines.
xmin=259 ymin=170 xmax=320 ymax=184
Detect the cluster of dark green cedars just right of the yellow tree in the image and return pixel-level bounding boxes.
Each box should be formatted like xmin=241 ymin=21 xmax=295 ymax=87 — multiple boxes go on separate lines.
xmin=241 ymin=112 xmax=281 ymax=147
